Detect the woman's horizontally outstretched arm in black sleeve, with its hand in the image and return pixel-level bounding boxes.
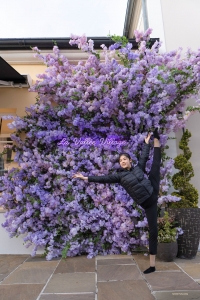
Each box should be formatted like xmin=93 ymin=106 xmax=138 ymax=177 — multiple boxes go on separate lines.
xmin=72 ymin=173 xmax=120 ymax=183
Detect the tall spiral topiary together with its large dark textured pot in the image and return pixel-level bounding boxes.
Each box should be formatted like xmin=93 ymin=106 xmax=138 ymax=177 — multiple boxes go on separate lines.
xmin=168 ymin=130 xmax=200 ymax=259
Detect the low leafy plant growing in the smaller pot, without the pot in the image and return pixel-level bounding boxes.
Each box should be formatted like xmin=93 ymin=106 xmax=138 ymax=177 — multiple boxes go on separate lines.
xmin=158 ymin=211 xmax=183 ymax=243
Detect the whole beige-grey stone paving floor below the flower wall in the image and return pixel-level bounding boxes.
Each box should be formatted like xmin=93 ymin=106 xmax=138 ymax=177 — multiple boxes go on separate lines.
xmin=0 ymin=252 xmax=200 ymax=300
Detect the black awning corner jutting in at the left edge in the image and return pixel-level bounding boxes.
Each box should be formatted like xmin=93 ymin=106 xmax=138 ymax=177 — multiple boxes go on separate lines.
xmin=0 ymin=56 xmax=27 ymax=86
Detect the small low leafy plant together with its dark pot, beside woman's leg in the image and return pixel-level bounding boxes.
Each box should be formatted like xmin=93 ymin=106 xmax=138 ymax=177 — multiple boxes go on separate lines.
xmin=157 ymin=211 xmax=182 ymax=261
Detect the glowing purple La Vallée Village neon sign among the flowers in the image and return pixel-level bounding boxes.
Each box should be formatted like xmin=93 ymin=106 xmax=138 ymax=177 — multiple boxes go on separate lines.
xmin=57 ymin=136 xmax=128 ymax=147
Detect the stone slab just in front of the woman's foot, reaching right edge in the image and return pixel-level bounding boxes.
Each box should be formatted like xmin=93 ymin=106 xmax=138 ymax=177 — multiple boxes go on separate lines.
xmin=144 ymin=272 xmax=200 ymax=291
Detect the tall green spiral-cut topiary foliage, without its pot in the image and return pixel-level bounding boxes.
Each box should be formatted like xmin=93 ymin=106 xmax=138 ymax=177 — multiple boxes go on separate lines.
xmin=169 ymin=129 xmax=198 ymax=208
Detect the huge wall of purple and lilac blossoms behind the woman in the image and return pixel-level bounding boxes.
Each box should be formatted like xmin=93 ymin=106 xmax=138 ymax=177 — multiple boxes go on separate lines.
xmin=0 ymin=29 xmax=200 ymax=259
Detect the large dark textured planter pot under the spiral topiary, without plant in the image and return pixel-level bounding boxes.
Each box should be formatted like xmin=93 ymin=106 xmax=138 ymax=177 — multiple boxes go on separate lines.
xmin=167 ymin=208 xmax=200 ymax=259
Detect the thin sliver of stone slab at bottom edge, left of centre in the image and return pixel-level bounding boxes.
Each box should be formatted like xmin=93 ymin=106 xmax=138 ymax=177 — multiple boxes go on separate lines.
xmin=39 ymin=293 xmax=95 ymax=300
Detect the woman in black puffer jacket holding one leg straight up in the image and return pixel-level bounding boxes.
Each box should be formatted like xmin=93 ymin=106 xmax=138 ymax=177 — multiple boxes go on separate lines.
xmin=72 ymin=128 xmax=161 ymax=274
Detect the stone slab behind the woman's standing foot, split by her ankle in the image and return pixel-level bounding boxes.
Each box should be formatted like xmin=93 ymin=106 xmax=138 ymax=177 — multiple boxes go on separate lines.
xmin=133 ymin=254 xmax=181 ymax=272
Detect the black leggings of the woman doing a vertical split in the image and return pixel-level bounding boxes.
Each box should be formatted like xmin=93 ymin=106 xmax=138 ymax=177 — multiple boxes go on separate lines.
xmin=141 ymin=147 xmax=161 ymax=255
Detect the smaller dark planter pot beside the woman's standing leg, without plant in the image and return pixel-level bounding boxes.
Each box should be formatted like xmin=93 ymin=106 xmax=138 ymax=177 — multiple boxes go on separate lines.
xmin=156 ymin=242 xmax=178 ymax=261
